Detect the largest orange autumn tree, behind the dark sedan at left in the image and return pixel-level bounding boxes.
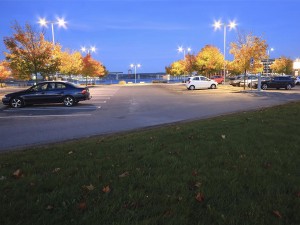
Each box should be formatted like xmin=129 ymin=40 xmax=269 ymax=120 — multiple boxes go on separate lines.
xmin=4 ymin=22 xmax=60 ymax=79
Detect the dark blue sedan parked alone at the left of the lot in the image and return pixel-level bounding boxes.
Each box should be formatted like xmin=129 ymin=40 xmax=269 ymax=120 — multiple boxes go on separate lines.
xmin=2 ymin=81 xmax=91 ymax=108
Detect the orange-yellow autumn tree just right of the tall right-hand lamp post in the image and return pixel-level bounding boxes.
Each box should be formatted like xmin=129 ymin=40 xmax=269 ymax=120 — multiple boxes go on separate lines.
xmin=229 ymin=33 xmax=268 ymax=73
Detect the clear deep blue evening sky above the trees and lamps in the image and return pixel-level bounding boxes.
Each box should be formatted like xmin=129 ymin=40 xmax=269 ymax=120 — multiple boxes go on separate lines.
xmin=0 ymin=0 xmax=300 ymax=73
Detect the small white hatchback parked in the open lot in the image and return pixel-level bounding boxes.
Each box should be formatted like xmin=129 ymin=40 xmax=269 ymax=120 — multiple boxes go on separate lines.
xmin=185 ymin=76 xmax=218 ymax=90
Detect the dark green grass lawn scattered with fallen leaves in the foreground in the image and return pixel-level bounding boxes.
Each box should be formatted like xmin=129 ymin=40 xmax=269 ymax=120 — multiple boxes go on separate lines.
xmin=0 ymin=103 xmax=300 ymax=225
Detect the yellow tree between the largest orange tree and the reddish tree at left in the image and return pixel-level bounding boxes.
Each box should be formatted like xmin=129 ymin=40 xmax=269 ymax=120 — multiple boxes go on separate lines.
xmin=59 ymin=50 xmax=83 ymax=75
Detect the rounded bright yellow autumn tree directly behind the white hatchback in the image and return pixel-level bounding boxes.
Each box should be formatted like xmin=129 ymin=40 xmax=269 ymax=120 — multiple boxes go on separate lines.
xmin=195 ymin=45 xmax=224 ymax=76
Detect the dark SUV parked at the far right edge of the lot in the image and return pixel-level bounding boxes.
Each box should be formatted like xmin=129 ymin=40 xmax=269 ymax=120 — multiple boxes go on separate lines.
xmin=261 ymin=76 xmax=295 ymax=90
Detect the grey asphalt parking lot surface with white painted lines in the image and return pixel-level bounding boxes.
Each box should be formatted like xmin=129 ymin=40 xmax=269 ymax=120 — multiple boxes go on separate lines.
xmin=0 ymin=84 xmax=300 ymax=152
